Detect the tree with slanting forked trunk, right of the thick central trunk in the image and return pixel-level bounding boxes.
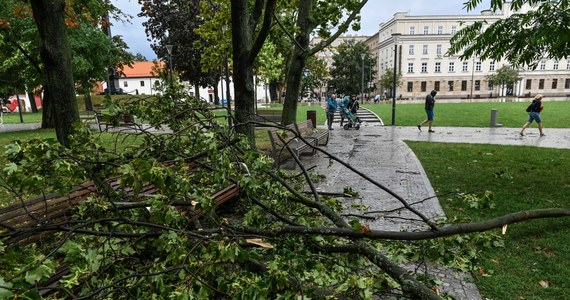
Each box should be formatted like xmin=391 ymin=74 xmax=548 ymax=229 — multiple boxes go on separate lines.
xmin=282 ymin=0 xmax=368 ymax=124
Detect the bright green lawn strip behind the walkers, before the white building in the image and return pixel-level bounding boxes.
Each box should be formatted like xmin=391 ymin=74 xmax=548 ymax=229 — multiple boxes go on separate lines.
xmin=362 ymin=100 xmax=570 ymax=128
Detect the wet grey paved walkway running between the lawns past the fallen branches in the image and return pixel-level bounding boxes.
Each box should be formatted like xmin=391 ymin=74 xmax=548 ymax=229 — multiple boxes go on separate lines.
xmin=302 ymin=124 xmax=570 ymax=299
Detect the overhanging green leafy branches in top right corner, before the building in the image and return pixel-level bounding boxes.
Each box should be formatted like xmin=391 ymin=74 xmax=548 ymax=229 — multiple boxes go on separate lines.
xmin=449 ymin=0 xmax=570 ymax=68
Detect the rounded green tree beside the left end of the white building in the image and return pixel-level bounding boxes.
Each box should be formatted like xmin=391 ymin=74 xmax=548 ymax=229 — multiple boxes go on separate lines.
xmin=330 ymin=40 xmax=374 ymax=95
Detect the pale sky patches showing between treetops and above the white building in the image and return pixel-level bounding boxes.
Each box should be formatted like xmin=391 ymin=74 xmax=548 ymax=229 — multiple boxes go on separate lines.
xmin=111 ymin=0 xmax=490 ymax=60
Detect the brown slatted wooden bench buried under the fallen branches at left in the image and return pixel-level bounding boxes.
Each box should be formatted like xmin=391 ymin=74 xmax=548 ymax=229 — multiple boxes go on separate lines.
xmin=0 ymin=164 xmax=239 ymax=297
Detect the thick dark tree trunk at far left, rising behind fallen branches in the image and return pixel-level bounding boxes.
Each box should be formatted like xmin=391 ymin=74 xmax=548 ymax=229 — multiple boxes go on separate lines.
xmin=30 ymin=0 xmax=79 ymax=146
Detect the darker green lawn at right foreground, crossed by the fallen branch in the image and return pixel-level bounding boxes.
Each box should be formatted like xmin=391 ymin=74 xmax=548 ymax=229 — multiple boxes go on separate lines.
xmin=407 ymin=142 xmax=570 ymax=300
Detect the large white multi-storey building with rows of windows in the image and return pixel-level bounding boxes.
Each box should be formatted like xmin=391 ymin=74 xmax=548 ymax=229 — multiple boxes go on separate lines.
xmin=371 ymin=3 xmax=570 ymax=99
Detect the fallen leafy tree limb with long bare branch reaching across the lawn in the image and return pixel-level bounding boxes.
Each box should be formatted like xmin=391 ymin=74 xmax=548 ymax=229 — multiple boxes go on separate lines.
xmin=0 ymin=94 xmax=570 ymax=299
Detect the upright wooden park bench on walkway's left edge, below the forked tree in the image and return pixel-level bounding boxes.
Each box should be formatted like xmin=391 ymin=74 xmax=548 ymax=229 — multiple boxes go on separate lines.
xmin=268 ymin=120 xmax=329 ymax=160
